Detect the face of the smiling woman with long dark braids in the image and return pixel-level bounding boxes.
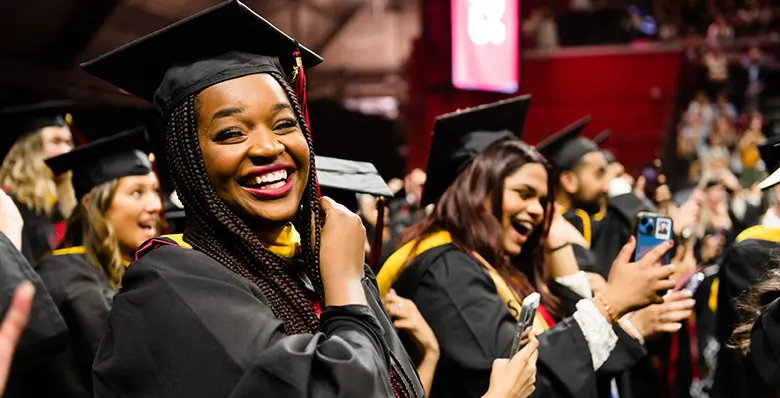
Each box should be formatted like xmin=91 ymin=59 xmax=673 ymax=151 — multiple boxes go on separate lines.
xmin=196 ymin=74 xmax=309 ymax=242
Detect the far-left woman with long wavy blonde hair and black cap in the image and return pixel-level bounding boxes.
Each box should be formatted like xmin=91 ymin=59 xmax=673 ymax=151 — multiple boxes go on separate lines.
xmin=0 ymin=101 xmax=75 ymax=264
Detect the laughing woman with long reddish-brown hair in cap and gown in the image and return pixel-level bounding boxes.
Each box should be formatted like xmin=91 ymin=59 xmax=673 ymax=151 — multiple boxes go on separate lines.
xmin=378 ymin=97 xmax=668 ymax=397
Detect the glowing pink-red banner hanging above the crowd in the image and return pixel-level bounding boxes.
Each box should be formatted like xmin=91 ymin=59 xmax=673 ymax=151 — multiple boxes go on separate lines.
xmin=452 ymin=0 xmax=519 ymax=93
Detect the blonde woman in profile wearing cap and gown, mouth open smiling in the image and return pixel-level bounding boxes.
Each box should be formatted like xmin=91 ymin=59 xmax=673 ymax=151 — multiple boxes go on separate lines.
xmin=9 ymin=130 xmax=162 ymax=397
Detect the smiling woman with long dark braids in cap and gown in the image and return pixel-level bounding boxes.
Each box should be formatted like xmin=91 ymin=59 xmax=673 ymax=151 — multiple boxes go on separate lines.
xmin=84 ymin=1 xmax=423 ymax=397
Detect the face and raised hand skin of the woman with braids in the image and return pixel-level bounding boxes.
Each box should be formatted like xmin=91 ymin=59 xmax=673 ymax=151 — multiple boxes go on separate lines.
xmin=196 ymin=74 xmax=366 ymax=306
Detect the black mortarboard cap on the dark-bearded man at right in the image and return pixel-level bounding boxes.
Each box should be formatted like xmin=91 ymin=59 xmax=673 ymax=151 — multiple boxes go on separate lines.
xmin=536 ymin=115 xmax=599 ymax=172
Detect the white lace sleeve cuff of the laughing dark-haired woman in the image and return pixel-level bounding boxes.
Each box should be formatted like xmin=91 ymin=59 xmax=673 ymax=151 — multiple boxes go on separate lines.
xmin=573 ymin=300 xmax=617 ymax=370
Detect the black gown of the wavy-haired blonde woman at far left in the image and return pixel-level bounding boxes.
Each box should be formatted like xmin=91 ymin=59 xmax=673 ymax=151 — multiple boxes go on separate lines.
xmin=10 ymin=194 xmax=62 ymax=264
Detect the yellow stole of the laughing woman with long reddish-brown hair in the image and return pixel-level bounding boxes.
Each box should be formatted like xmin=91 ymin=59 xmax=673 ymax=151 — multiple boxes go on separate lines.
xmin=376 ymin=231 xmax=550 ymax=334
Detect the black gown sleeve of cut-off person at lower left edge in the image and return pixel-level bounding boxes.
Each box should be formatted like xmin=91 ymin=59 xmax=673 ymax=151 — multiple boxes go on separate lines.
xmin=0 ymin=233 xmax=68 ymax=397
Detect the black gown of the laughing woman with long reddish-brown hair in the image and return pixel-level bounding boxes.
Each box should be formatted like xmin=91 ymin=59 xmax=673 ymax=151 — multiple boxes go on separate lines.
xmin=393 ymin=244 xmax=644 ymax=398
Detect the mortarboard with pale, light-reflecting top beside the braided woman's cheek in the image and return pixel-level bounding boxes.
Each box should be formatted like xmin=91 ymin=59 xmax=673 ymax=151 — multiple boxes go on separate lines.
xmin=315 ymin=156 xmax=393 ymax=212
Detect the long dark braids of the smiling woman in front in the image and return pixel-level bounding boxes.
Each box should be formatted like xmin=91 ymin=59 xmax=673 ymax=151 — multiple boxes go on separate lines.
xmin=165 ymin=73 xmax=324 ymax=335
